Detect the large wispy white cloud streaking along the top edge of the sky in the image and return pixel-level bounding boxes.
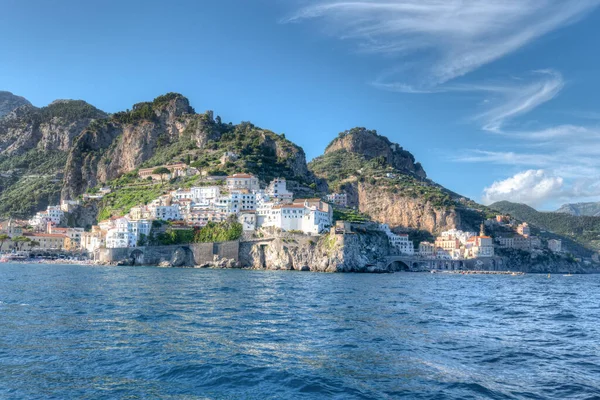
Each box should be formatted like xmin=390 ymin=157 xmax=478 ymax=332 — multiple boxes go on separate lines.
xmin=283 ymin=0 xmax=600 ymax=93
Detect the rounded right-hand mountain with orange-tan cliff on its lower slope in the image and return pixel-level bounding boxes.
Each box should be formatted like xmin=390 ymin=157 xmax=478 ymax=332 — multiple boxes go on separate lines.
xmin=309 ymin=128 xmax=485 ymax=233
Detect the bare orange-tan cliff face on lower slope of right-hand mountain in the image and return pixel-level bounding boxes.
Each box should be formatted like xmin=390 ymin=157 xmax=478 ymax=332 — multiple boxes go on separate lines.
xmin=357 ymin=183 xmax=461 ymax=233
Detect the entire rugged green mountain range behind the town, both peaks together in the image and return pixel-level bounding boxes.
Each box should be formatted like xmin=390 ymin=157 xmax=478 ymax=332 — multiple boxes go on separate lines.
xmin=0 ymin=93 xmax=488 ymax=235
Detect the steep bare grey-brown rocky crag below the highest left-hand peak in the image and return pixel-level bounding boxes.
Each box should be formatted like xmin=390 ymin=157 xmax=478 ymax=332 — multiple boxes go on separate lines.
xmin=61 ymin=95 xmax=220 ymax=199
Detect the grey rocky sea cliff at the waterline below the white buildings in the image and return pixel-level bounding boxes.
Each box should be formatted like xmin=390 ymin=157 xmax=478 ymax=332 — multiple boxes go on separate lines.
xmin=240 ymin=232 xmax=398 ymax=272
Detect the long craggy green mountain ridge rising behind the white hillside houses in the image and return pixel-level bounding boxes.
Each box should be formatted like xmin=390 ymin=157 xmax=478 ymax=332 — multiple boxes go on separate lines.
xmin=0 ymin=93 xmax=317 ymax=218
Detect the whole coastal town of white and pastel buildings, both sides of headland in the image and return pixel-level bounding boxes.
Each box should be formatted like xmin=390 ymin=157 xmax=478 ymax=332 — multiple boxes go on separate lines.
xmin=0 ymin=163 xmax=576 ymax=268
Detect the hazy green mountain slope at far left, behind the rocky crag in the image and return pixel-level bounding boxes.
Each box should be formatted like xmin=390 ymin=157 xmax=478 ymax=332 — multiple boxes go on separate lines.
xmin=0 ymin=100 xmax=107 ymax=218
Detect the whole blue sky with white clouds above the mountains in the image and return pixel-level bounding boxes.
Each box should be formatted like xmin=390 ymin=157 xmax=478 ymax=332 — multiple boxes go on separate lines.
xmin=0 ymin=0 xmax=600 ymax=209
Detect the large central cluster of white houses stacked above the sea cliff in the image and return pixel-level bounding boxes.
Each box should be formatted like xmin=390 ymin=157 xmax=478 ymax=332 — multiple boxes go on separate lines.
xmin=76 ymin=174 xmax=333 ymax=251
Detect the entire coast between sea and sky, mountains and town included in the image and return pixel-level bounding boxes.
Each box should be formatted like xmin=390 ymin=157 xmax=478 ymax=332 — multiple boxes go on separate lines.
xmin=0 ymin=92 xmax=600 ymax=272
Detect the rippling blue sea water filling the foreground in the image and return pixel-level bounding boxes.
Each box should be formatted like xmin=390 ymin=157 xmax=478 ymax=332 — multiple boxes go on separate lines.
xmin=0 ymin=264 xmax=600 ymax=399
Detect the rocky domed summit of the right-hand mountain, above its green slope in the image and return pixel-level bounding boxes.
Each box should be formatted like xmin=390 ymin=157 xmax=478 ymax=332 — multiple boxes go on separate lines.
xmin=325 ymin=128 xmax=427 ymax=178
